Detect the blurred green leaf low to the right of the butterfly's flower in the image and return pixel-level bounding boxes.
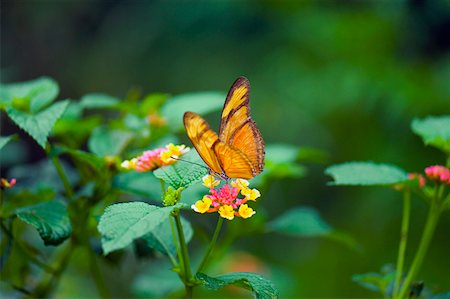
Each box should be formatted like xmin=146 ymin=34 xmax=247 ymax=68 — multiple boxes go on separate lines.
xmin=267 ymin=207 xmax=333 ymax=237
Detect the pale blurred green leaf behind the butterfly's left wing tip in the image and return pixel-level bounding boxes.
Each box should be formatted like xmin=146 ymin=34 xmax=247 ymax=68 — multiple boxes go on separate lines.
xmin=161 ymin=92 xmax=226 ymax=130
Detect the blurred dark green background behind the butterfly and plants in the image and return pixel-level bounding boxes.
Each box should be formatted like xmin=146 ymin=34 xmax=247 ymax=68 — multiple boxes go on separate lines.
xmin=0 ymin=0 xmax=450 ymax=298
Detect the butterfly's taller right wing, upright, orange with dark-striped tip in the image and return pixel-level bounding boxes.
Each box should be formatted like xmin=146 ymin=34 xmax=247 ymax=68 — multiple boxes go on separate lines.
xmin=217 ymin=77 xmax=264 ymax=178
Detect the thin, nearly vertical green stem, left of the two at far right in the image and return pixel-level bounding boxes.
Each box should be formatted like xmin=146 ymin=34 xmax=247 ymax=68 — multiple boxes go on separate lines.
xmin=392 ymin=189 xmax=411 ymax=298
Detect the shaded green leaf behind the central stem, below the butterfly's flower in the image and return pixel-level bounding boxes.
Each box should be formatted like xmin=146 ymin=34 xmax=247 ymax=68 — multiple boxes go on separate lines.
xmin=143 ymin=217 xmax=194 ymax=258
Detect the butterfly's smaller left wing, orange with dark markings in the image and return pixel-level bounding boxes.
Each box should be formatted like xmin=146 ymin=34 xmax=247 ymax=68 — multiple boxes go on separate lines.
xmin=183 ymin=112 xmax=223 ymax=173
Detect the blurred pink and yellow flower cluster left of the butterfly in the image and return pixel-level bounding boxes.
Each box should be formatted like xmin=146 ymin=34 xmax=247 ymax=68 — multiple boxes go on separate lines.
xmin=120 ymin=143 xmax=189 ymax=172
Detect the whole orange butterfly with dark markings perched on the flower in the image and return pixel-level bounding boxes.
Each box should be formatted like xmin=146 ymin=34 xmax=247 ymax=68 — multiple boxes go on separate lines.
xmin=183 ymin=77 xmax=264 ymax=180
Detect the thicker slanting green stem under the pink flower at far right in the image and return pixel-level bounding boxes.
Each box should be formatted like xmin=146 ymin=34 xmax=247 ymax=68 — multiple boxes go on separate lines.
xmin=396 ymin=198 xmax=441 ymax=299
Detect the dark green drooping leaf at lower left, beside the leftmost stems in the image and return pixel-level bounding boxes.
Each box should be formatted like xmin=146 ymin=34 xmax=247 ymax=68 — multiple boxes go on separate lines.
xmin=16 ymin=200 xmax=72 ymax=245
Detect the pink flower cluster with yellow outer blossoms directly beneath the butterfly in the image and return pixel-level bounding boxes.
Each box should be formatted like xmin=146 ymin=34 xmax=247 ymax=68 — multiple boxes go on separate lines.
xmin=192 ymin=175 xmax=261 ymax=220
